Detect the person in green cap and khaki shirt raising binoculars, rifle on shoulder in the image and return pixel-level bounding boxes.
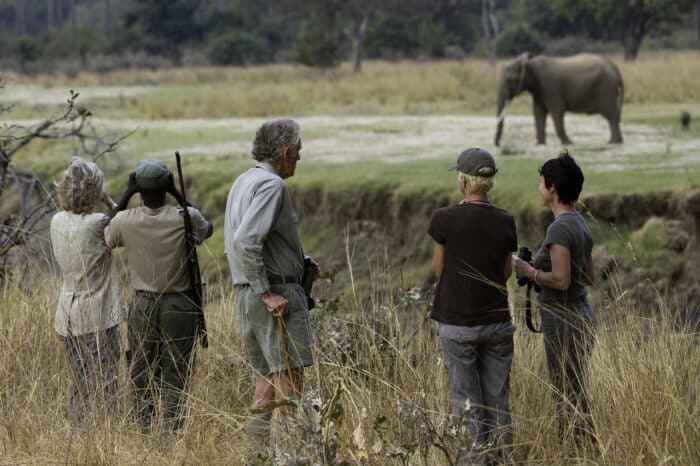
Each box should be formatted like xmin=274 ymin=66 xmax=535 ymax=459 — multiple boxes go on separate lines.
xmin=105 ymin=159 xmax=213 ymax=430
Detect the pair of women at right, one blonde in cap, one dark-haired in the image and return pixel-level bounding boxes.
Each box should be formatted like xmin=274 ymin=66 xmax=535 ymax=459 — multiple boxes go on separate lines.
xmin=428 ymin=148 xmax=597 ymax=464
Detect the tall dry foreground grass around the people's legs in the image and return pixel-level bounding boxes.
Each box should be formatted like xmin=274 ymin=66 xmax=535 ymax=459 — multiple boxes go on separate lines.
xmin=0 ymin=246 xmax=700 ymax=465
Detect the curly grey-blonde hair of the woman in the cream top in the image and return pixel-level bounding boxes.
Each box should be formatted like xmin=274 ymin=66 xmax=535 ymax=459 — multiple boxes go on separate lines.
xmin=56 ymin=157 xmax=104 ymax=214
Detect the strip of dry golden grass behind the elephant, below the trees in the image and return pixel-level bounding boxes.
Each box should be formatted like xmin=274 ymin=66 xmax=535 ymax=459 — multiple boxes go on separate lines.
xmin=7 ymin=51 xmax=700 ymax=118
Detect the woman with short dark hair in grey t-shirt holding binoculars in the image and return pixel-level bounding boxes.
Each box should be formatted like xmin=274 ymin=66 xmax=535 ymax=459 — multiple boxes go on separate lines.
xmin=513 ymin=152 xmax=595 ymax=442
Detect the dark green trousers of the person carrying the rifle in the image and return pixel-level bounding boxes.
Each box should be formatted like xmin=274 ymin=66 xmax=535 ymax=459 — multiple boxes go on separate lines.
xmin=128 ymin=290 xmax=198 ymax=429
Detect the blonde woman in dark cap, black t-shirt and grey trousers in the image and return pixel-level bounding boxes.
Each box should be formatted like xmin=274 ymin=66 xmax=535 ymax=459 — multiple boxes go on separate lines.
xmin=428 ymin=148 xmax=518 ymax=464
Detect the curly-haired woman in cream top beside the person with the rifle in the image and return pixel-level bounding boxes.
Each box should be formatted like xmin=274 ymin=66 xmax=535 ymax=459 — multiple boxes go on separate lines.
xmin=51 ymin=157 xmax=125 ymax=424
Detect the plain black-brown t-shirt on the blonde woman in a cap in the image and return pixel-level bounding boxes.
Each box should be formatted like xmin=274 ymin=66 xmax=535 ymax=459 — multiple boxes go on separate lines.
xmin=428 ymin=202 xmax=518 ymax=325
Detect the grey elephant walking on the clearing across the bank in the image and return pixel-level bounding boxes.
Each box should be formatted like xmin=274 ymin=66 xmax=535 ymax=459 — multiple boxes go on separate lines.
xmin=495 ymin=53 xmax=624 ymax=146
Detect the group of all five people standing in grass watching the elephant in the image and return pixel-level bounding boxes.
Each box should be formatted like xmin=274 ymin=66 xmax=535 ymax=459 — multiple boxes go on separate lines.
xmin=51 ymin=119 xmax=595 ymax=463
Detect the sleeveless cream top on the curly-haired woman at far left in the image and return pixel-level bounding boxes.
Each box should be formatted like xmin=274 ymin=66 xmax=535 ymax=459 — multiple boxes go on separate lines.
xmin=51 ymin=211 xmax=125 ymax=336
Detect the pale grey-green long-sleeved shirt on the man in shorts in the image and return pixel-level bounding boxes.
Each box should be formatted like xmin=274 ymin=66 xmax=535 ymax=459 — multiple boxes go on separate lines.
xmin=224 ymin=162 xmax=304 ymax=294
